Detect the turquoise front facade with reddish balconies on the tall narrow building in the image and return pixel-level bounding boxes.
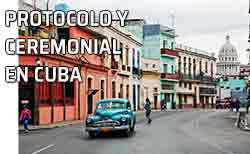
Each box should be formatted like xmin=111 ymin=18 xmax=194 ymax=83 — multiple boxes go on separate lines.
xmin=160 ymin=26 xmax=178 ymax=109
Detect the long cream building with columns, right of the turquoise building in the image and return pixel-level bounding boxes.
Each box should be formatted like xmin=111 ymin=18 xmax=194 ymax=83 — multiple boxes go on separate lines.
xmin=176 ymin=45 xmax=216 ymax=108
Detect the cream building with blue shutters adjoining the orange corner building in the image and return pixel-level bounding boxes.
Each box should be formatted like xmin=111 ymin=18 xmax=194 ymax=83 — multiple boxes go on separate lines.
xmin=84 ymin=27 xmax=142 ymax=111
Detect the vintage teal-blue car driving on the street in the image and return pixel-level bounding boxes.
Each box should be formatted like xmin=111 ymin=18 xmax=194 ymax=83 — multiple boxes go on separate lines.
xmin=86 ymin=99 xmax=136 ymax=138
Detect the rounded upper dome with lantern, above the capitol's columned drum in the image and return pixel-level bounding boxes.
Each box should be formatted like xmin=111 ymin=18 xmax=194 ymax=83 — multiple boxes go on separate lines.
xmin=219 ymin=35 xmax=238 ymax=62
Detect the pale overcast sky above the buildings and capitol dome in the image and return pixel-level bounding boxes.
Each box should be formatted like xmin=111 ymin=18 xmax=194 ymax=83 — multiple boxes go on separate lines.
xmin=59 ymin=0 xmax=250 ymax=63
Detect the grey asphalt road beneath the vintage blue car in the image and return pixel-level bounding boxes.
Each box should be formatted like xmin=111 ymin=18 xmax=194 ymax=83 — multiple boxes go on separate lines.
xmin=19 ymin=111 xmax=250 ymax=154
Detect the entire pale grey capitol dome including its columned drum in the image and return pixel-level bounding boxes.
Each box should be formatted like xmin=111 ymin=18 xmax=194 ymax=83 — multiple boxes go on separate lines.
xmin=216 ymin=35 xmax=240 ymax=76
